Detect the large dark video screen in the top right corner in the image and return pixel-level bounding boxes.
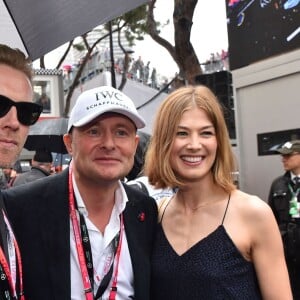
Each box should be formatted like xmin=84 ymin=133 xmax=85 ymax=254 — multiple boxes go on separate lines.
xmin=226 ymin=0 xmax=300 ymax=70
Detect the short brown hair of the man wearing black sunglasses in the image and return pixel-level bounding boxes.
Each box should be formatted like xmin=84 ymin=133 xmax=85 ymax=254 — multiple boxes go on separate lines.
xmin=0 ymin=44 xmax=33 ymax=83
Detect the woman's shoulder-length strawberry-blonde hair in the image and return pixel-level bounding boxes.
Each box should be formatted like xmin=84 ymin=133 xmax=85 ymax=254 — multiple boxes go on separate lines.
xmin=144 ymin=86 xmax=236 ymax=192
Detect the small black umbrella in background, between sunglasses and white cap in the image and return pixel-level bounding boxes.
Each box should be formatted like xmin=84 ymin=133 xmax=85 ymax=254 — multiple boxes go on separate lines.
xmin=24 ymin=118 xmax=68 ymax=154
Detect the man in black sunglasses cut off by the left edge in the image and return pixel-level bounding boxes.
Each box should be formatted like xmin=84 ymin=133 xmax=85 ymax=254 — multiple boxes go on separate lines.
xmin=0 ymin=44 xmax=42 ymax=300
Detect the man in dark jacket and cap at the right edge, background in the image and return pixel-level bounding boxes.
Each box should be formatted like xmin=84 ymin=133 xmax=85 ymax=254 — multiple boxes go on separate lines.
xmin=269 ymin=140 xmax=300 ymax=299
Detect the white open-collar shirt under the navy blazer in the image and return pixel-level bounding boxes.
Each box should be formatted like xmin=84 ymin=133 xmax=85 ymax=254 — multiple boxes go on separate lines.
xmin=70 ymin=177 xmax=134 ymax=300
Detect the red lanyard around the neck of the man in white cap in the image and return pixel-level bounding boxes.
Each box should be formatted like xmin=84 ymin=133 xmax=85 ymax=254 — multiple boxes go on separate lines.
xmin=69 ymin=164 xmax=124 ymax=300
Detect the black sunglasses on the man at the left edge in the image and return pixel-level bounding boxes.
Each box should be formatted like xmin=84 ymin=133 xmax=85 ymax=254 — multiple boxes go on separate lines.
xmin=0 ymin=95 xmax=43 ymax=126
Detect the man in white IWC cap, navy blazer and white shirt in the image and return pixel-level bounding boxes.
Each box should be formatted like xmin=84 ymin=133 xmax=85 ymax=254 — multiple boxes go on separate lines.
xmin=6 ymin=86 xmax=157 ymax=300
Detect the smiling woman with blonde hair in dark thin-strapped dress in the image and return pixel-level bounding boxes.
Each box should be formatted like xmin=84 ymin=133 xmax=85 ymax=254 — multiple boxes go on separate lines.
xmin=145 ymin=86 xmax=292 ymax=300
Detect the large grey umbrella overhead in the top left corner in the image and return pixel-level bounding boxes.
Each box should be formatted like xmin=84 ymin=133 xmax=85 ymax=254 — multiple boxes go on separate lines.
xmin=0 ymin=0 xmax=147 ymax=60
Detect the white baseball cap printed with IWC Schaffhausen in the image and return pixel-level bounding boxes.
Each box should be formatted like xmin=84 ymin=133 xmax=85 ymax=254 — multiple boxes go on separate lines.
xmin=68 ymin=86 xmax=145 ymax=132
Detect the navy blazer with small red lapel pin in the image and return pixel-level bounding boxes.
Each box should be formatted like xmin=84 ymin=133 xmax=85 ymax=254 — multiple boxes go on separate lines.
xmin=3 ymin=169 xmax=157 ymax=300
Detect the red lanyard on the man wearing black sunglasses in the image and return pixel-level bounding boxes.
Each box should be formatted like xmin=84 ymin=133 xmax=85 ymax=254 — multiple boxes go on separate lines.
xmin=0 ymin=211 xmax=25 ymax=300
